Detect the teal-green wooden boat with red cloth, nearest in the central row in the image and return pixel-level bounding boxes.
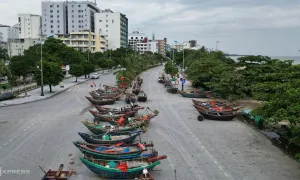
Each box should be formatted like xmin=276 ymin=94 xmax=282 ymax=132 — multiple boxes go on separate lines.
xmin=80 ymin=155 xmax=167 ymax=179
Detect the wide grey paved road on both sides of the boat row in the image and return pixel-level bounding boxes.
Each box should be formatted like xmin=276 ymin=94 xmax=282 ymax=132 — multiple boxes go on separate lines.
xmin=0 ymin=67 xmax=300 ymax=180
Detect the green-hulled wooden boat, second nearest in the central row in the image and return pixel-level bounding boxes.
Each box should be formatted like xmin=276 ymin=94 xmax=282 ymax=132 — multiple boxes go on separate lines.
xmin=73 ymin=141 xmax=153 ymax=160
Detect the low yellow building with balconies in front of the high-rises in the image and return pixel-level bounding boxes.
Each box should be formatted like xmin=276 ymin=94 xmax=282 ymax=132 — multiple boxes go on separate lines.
xmin=55 ymin=31 xmax=106 ymax=52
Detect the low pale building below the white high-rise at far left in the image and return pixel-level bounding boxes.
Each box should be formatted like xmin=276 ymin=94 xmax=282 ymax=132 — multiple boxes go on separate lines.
xmin=7 ymin=38 xmax=40 ymax=57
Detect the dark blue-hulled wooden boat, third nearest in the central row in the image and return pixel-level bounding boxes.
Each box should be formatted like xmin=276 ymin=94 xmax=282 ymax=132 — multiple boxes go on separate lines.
xmin=78 ymin=130 xmax=142 ymax=144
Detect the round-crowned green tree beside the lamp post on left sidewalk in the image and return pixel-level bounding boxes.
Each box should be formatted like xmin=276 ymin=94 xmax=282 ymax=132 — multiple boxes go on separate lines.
xmin=34 ymin=60 xmax=64 ymax=92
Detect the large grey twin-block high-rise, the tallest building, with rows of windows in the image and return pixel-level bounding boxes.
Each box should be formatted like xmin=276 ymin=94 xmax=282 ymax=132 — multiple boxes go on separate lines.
xmin=42 ymin=1 xmax=100 ymax=36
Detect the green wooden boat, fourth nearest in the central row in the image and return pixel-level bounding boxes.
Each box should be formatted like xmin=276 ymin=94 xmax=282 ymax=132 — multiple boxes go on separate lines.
xmin=82 ymin=121 xmax=144 ymax=134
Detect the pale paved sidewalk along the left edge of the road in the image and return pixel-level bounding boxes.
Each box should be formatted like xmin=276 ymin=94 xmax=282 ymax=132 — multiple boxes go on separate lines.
xmin=0 ymin=70 xmax=114 ymax=108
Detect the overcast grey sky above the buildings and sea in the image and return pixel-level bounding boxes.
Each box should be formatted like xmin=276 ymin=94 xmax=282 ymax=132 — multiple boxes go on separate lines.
xmin=0 ymin=0 xmax=300 ymax=56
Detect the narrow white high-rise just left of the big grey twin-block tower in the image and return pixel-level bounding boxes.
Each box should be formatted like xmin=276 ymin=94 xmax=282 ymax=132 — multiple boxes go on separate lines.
xmin=18 ymin=14 xmax=42 ymax=38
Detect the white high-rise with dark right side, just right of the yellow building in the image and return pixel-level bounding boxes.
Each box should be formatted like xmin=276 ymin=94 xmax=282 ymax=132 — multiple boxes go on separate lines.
xmin=95 ymin=9 xmax=128 ymax=49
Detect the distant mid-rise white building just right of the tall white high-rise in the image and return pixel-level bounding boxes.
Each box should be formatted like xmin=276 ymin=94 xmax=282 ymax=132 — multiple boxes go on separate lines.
xmin=128 ymin=31 xmax=150 ymax=54
